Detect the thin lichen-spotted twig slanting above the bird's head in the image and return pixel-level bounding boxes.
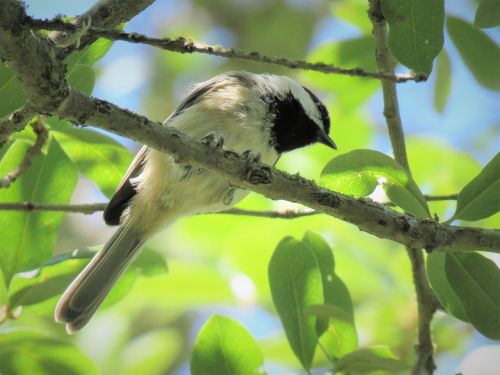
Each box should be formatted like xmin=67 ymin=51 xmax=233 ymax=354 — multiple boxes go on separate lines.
xmin=26 ymin=18 xmax=425 ymax=83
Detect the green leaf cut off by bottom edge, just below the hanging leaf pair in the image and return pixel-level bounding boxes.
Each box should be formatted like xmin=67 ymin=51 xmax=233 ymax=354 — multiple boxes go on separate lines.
xmin=334 ymin=346 xmax=411 ymax=374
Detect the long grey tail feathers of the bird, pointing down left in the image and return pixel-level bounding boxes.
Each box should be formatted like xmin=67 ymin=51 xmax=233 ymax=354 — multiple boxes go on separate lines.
xmin=55 ymin=226 xmax=142 ymax=334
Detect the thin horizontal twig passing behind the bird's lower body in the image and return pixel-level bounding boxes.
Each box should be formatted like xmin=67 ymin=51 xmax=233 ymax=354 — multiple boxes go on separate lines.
xmin=0 ymin=194 xmax=457 ymax=214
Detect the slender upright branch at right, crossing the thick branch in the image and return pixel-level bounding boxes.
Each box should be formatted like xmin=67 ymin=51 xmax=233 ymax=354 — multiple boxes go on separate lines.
xmin=369 ymin=0 xmax=437 ymax=375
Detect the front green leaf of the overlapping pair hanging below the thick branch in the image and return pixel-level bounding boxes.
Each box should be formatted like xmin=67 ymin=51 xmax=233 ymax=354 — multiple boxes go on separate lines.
xmin=268 ymin=237 xmax=323 ymax=370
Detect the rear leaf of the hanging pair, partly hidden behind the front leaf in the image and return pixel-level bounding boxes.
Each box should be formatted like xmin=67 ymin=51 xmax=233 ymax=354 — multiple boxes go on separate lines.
xmin=302 ymin=231 xmax=358 ymax=358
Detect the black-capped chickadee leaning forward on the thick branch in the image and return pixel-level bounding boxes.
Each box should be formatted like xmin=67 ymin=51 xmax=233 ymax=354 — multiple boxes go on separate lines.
xmin=55 ymin=72 xmax=336 ymax=333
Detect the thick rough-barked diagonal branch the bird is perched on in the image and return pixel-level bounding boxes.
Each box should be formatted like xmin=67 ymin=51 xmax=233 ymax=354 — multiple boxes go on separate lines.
xmin=58 ymin=91 xmax=500 ymax=251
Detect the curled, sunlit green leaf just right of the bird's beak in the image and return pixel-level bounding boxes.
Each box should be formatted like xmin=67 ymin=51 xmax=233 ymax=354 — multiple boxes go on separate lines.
xmin=320 ymin=150 xmax=430 ymax=217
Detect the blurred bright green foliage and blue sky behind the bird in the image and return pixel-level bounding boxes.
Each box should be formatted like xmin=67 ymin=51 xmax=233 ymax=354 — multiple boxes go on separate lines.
xmin=0 ymin=0 xmax=500 ymax=374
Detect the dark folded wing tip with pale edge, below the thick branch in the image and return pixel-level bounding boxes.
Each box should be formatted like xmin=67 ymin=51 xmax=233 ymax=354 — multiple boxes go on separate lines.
xmin=103 ymin=146 xmax=149 ymax=225
